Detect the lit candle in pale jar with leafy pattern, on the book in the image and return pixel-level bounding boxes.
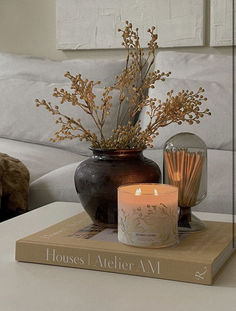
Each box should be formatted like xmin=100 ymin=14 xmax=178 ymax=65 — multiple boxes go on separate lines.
xmin=118 ymin=184 xmax=178 ymax=248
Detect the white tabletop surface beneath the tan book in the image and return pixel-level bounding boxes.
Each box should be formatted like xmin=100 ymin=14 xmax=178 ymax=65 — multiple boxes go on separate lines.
xmin=0 ymin=202 xmax=236 ymax=311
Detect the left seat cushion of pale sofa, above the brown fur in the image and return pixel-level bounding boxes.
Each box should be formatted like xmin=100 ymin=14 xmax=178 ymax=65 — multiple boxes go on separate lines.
xmin=0 ymin=138 xmax=85 ymax=182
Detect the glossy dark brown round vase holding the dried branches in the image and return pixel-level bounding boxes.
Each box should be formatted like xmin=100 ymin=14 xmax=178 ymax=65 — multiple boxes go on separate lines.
xmin=75 ymin=149 xmax=161 ymax=227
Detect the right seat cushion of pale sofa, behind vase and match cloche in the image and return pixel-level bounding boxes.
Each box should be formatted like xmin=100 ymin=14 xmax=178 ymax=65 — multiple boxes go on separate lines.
xmin=30 ymin=150 xmax=233 ymax=214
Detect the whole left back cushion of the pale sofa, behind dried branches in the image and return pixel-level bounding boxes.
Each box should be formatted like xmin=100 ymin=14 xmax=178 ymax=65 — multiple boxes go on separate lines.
xmin=0 ymin=53 xmax=129 ymax=155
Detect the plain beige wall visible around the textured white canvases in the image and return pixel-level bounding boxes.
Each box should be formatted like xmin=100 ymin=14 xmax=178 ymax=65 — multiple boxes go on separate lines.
xmin=0 ymin=0 xmax=232 ymax=60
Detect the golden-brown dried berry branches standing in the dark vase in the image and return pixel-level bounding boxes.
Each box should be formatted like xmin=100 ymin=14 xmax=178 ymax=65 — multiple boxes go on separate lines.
xmin=36 ymin=21 xmax=210 ymax=149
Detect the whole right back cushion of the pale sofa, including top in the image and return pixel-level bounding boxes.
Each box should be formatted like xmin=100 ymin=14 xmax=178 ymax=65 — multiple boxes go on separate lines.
xmin=139 ymin=51 xmax=232 ymax=150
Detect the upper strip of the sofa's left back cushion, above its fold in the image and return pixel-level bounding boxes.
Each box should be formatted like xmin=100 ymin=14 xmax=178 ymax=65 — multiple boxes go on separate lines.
xmin=0 ymin=53 xmax=126 ymax=86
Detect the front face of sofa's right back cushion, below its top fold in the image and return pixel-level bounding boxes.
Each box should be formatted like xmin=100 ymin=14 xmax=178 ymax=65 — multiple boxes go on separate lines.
xmin=139 ymin=78 xmax=232 ymax=150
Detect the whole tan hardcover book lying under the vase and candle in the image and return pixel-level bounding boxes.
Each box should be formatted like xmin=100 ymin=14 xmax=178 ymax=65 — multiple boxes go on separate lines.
xmin=16 ymin=212 xmax=234 ymax=285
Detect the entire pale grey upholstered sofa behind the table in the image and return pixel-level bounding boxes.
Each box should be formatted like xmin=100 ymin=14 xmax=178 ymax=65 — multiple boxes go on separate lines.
xmin=0 ymin=51 xmax=233 ymax=217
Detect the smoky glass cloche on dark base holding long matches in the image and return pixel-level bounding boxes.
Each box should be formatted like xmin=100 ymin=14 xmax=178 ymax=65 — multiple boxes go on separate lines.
xmin=163 ymin=133 xmax=207 ymax=231
